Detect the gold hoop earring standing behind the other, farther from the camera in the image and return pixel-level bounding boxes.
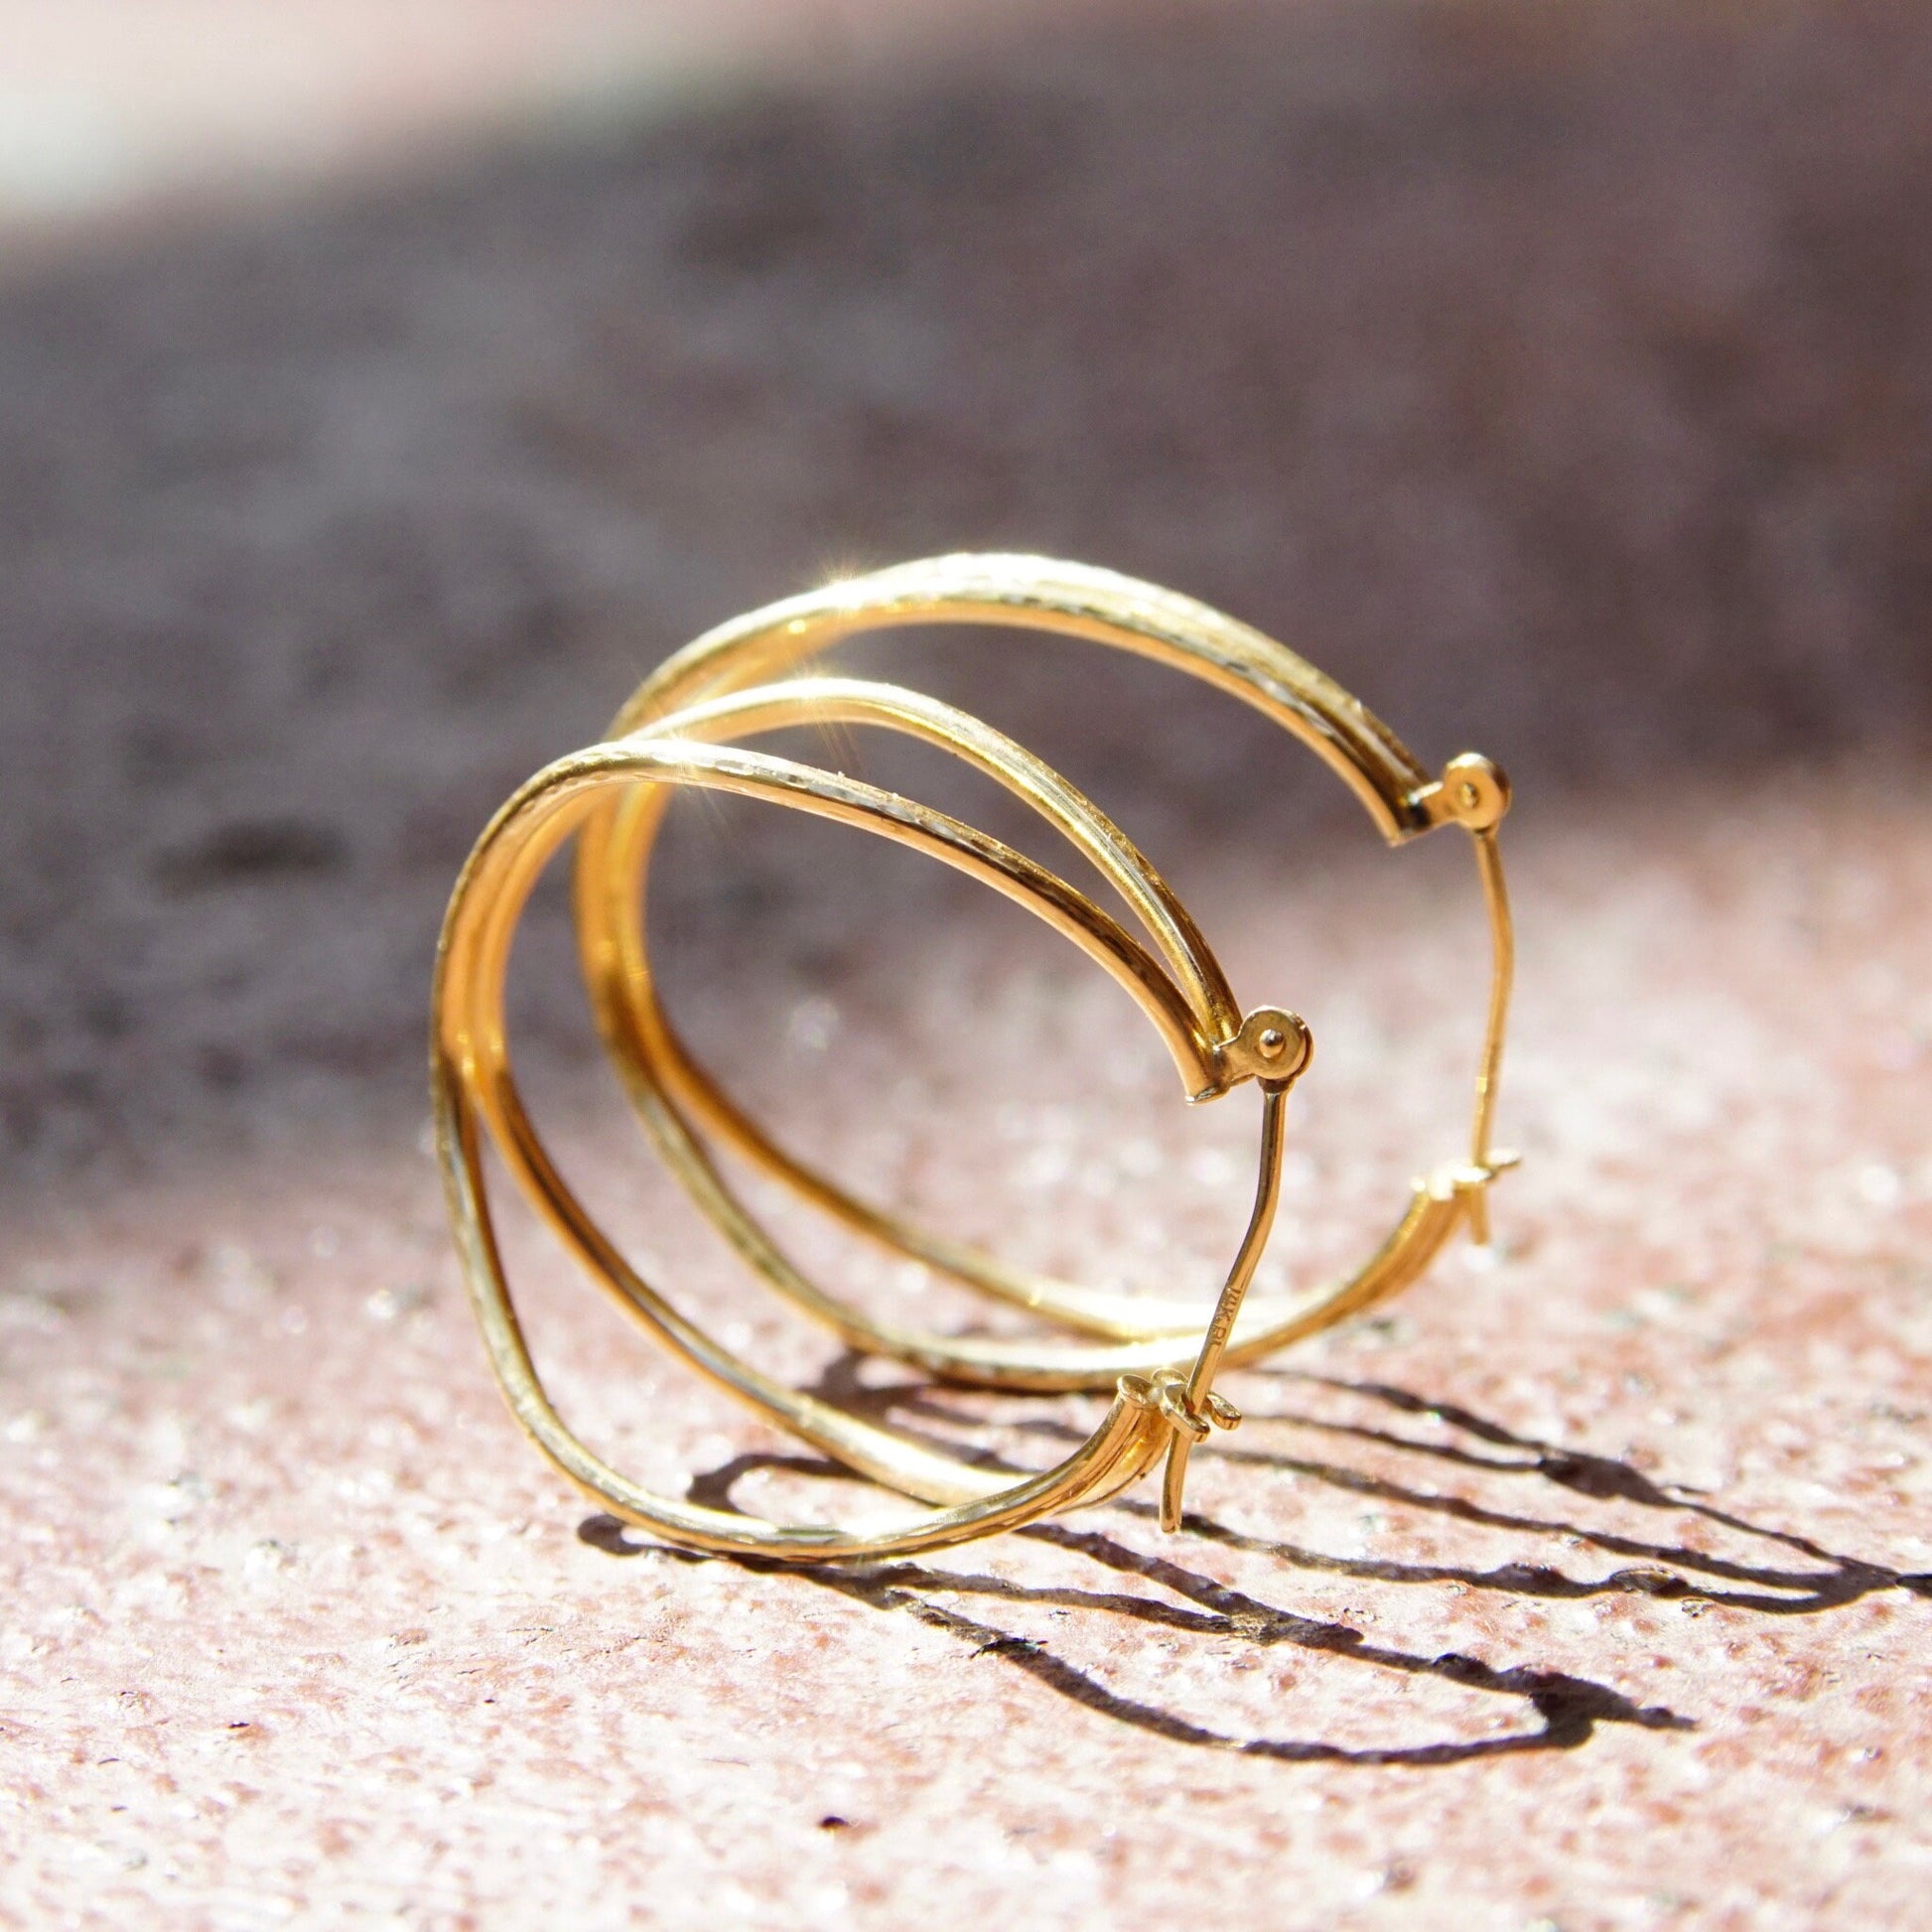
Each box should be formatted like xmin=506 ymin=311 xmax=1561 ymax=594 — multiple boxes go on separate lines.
xmin=576 ymin=556 xmax=1515 ymax=1389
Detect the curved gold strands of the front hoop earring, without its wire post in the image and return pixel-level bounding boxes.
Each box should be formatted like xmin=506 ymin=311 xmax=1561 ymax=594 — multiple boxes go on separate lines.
xmin=433 ymin=726 xmax=1306 ymax=1559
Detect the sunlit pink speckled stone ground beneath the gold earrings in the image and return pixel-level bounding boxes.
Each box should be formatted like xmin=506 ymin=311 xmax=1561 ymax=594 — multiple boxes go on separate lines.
xmin=0 ymin=780 xmax=1932 ymax=1928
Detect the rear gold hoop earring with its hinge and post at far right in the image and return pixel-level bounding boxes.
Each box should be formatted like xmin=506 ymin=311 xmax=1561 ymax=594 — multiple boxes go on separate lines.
xmin=578 ymin=556 xmax=1513 ymax=1387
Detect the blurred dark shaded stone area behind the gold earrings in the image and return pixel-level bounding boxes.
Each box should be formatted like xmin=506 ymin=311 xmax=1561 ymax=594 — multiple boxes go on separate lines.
xmin=0 ymin=0 xmax=1932 ymax=1176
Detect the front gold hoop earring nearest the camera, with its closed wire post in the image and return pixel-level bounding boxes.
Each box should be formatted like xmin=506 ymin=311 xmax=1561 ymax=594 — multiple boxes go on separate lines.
xmin=431 ymin=726 xmax=1310 ymax=1561
